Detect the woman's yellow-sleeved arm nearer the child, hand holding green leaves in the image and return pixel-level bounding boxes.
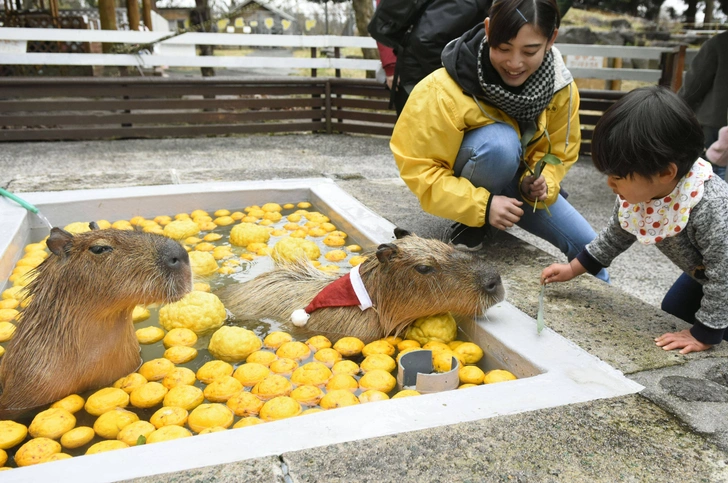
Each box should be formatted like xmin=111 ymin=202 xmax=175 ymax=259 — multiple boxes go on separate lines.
xmin=521 ymin=82 xmax=581 ymax=208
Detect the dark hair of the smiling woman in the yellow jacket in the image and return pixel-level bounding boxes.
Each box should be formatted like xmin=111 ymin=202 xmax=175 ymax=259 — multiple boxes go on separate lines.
xmin=488 ymin=0 xmax=561 ymax=47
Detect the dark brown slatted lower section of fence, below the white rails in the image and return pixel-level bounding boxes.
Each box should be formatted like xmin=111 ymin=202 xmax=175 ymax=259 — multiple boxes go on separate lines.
xmin=0 ymin=77 xmax=625 ymax=153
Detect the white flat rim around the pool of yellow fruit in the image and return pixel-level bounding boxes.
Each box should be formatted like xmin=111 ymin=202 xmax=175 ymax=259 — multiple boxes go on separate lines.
xmin=0 ymin=179 xmax=642 ymax=483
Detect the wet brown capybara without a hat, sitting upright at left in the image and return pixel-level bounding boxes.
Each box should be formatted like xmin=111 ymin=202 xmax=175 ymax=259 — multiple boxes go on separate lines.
xmin=0 ymin=223 xmax=192 ymax=418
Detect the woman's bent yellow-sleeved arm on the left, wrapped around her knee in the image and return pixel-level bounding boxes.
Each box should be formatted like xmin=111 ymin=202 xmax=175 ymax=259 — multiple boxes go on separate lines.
xmin=390 ymin=69 xmax=491 ymax=226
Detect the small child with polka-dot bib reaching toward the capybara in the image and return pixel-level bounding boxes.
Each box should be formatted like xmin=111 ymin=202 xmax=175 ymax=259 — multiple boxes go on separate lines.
xmin=541 ymin=86 xmax=728 ymax=354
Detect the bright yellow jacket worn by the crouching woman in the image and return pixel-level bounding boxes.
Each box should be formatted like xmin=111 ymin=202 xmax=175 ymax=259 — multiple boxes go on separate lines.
xmin=390 ymin=27 xmax=581 ymax=230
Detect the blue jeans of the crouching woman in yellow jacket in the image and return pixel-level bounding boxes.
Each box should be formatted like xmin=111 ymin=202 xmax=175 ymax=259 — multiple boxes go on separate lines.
xmin=453 ymin=123 xmax=609 ymax=282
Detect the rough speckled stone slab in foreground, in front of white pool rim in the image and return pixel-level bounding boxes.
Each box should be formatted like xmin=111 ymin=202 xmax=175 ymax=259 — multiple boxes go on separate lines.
xmin=131 ymin=395 xmax=728 ymax=483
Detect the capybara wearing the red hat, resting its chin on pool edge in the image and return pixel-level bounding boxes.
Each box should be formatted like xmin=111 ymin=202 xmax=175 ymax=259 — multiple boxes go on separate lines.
xmin=218 ymin=229 xmax=505 ymax=342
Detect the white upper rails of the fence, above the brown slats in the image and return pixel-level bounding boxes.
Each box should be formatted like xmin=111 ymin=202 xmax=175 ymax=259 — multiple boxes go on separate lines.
xmin=0 ymin=28 xmax=697 ymax=83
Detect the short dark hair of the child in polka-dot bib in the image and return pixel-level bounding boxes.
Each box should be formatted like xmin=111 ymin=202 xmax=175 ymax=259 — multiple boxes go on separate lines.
xmin=591 ymin=86 xmax=703 ymax=178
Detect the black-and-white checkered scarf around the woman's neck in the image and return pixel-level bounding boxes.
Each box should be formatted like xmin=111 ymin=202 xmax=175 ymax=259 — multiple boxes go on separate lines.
xmin=478 ymin=37 xmax=556 ymax=121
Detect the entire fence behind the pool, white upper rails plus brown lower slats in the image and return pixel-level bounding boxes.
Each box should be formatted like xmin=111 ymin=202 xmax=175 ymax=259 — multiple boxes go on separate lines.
xmin=0 ymin=28 xmax=684 ymax=153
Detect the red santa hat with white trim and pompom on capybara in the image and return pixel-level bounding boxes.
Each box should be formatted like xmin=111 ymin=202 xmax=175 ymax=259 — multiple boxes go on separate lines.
xmin=291 ymin=265 xmax=372 ymax=327
